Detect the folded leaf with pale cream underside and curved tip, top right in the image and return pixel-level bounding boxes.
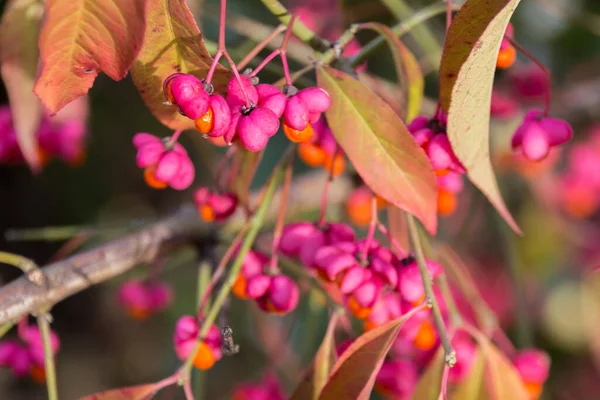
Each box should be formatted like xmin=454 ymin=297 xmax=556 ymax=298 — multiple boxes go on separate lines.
xmin=440 ymin=0 xmax=521 ymax=234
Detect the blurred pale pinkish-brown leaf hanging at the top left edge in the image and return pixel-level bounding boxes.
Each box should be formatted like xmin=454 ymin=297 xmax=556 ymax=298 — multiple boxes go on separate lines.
xmin=0 ymin=0 xmax=44 ymax=171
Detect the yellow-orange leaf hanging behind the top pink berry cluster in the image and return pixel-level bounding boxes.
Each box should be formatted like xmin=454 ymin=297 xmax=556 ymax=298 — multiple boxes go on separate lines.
xmin=131 ymin=0 xmax=231 ymax=129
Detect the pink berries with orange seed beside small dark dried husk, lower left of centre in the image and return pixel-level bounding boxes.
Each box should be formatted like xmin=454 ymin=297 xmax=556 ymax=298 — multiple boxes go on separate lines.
xmin=173 ymin=315 xmax=223 ymax=370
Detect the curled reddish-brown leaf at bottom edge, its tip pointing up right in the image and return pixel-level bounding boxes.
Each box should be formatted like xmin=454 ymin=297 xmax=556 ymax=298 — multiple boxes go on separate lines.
xmin=319 ymin=307 xmax=423 ymax=400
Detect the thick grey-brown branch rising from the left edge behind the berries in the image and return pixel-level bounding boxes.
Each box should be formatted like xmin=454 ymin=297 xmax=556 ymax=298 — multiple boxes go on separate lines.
xmin=0 ymin=172 xmax=351 ymax=325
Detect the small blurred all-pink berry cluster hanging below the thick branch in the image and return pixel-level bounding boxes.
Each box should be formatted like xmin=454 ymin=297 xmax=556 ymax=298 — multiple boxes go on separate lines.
xmin=118 ymin=279 xmax=173 ymax=320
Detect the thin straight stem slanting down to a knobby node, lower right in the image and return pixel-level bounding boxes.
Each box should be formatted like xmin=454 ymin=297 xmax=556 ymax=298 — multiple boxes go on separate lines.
xmin=406 ymin=214 xmax=456 ymax=367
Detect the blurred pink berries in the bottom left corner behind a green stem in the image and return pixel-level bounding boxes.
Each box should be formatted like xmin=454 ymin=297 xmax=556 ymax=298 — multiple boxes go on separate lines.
xmin=0 ymin=321 xmax=60 ymax=383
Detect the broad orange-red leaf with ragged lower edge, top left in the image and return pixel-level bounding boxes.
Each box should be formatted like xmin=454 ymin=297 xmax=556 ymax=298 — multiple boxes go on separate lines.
xmin=34 ymin=0 xmax=147 ymax=112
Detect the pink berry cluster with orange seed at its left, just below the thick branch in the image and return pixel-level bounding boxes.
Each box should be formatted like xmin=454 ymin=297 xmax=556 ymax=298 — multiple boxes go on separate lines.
xmin=232 ymin=251 xmax=300 ymax=314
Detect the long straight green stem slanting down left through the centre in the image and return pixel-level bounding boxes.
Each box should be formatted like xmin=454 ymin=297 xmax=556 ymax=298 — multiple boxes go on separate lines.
xmin=180 ymin=162 xmax=285 ymax=381
